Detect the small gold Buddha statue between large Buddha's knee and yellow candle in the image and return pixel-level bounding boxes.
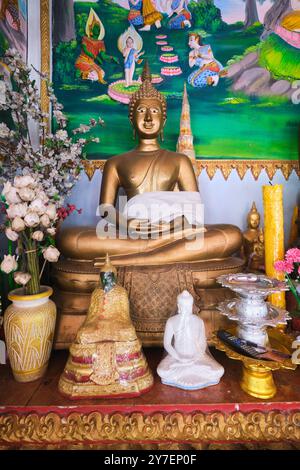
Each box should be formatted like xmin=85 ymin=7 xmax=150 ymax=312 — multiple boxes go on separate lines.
xmin=243 ymin=202 xmax=264 ymax=270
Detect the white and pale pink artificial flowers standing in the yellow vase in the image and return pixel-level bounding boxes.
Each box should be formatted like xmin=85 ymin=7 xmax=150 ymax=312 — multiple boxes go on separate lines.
xmin=0 ymin=49 xmax=103 ymax=295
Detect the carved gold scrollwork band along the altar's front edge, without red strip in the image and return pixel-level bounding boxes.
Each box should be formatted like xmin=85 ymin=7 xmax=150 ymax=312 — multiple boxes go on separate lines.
xmin=0 ymin=411 xmax=300 ymax=445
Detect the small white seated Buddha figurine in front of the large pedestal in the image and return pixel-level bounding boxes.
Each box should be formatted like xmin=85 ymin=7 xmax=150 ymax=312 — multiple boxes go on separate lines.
xmin=157 ymin=290 xmax=224 ymax=390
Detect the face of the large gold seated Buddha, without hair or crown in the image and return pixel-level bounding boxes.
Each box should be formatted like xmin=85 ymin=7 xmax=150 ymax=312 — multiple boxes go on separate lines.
xmin=133 ymin=98 xmax=165 ymax=139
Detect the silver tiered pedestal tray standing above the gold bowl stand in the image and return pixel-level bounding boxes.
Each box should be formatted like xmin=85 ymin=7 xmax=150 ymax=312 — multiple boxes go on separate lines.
xmin=217 ymin=273 xmax=290 ymax=346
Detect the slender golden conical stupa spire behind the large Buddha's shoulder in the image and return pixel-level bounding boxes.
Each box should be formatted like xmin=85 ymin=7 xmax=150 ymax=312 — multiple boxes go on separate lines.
xmin=176 ymin=84 xmax=196 ymax=160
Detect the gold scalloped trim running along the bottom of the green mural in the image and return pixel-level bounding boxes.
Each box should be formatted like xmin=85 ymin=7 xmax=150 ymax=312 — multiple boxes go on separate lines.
xmin=83 ymin=159 xmax=300 ymax=180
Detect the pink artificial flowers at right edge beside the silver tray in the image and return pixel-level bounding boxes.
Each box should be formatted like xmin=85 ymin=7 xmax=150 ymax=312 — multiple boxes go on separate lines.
xmin=274 ymin=248 xmax=300 ymax=317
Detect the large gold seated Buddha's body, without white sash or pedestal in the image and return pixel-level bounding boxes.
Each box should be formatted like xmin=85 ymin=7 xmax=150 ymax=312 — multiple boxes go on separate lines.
xmin=57 ymin=62 xmax=242 ymax=266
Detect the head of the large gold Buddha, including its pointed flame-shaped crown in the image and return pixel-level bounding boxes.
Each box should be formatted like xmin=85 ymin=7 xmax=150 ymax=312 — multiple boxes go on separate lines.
xmin=129 ymin=62 xmax=167 ymax=139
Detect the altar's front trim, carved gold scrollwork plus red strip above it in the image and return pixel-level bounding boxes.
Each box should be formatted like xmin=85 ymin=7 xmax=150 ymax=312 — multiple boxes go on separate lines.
xmin=0 ymin=403 xmax=300 ymax=447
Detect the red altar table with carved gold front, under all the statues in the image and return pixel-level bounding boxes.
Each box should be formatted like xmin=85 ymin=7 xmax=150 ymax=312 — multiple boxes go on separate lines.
xmin=0 ymin=349 xmax=300 ymax=448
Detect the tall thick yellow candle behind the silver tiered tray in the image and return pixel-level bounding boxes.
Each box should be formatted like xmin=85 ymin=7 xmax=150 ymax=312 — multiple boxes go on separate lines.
xmin=263 ymin=184 xmax=285 ymax=308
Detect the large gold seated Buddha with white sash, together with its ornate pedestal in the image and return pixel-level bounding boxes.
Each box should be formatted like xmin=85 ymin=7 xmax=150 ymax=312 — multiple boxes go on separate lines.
xmin=53 ymin=62 xmax=244 ymax=347
